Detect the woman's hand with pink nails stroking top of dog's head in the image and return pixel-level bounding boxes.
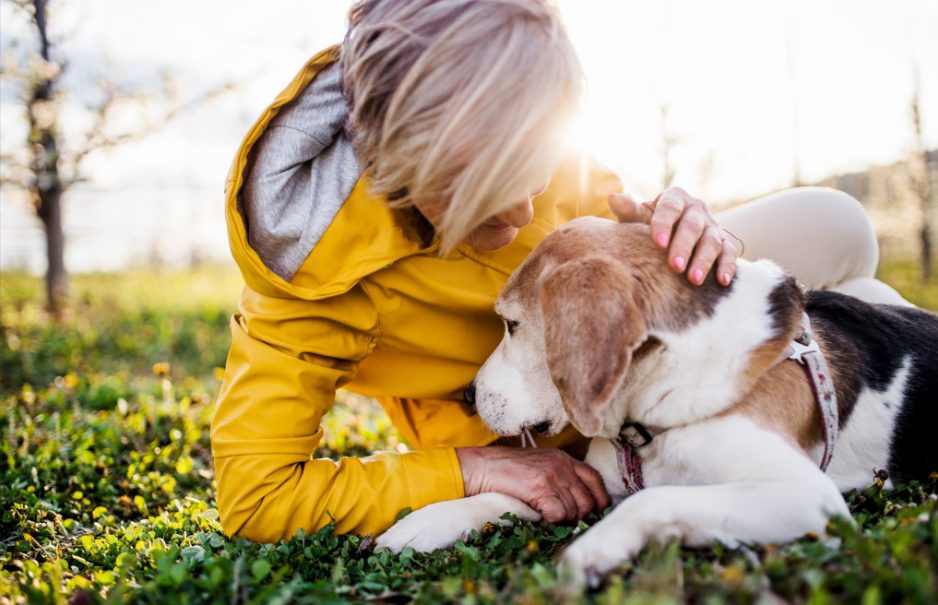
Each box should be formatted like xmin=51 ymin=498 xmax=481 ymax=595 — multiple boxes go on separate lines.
xmin=609 ymin=187 xmax=739 ymax=286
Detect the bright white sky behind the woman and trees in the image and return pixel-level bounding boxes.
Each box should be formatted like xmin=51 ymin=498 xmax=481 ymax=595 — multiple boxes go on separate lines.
xmin=0 ymin=0 xmax=938 ymax=271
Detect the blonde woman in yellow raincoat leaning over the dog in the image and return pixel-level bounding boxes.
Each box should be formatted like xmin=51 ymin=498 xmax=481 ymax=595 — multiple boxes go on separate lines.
xmin=212 ymin=0 xmax=893 ymax=541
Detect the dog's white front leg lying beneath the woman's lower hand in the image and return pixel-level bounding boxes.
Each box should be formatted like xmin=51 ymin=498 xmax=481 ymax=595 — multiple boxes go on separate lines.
xmin=375 ymin=493 xmax=541 ymax=552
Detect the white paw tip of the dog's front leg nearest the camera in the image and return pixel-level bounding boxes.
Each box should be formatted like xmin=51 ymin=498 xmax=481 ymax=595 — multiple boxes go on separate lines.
xmin=560 ymin=518 xmax=643 ymax=590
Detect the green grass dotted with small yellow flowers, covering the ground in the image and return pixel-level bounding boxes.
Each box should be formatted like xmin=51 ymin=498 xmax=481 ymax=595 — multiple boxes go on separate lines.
xmin=0 ymin=263 xmax=938 ymax=605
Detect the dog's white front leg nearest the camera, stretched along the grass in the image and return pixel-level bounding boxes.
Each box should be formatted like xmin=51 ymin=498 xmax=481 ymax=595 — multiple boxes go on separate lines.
xmin=562 ymin=470 xmax=850 ymax=585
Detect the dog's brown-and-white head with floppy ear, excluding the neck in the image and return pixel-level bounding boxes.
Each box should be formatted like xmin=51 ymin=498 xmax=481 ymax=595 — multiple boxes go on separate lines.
xmin=475 ymin=219 xmax=664 ymax=436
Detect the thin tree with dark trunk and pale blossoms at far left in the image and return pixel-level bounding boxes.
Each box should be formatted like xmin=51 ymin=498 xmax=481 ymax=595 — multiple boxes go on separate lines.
xmin=0 ymin=0 xmax=233 ymax=314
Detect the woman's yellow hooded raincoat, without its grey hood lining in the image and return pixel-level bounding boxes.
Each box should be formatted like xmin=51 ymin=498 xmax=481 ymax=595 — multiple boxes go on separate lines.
xmin=211 ymin=48 xmax=621 ymax=542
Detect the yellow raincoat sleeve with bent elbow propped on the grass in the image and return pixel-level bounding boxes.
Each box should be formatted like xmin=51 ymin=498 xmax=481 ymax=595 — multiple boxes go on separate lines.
xmin=212 ymin=285 xmax=463 ymax=542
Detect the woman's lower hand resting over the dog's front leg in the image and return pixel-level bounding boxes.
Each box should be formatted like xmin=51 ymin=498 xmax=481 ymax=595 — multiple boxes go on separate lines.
xmin=456 ymin=446 xmax=609 ymax=523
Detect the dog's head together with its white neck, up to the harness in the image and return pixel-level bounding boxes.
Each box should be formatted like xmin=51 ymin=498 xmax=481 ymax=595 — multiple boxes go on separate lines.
xmin=475 ymin=218 xmax=804 ymax=438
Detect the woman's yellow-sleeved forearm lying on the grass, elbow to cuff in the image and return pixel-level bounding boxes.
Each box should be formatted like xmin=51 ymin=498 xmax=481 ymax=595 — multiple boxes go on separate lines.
xmin=215 ymin=448 xmax=463 ymax=542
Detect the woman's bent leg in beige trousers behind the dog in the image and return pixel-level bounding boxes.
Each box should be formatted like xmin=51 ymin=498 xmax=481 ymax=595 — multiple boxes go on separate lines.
xmin=717 ymin=187 xmax=909 ymax=305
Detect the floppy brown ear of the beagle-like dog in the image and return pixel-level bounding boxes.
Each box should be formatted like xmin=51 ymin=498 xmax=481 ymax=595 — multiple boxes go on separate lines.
xmin=538 ymin=258 xmax=647 ymax=437
